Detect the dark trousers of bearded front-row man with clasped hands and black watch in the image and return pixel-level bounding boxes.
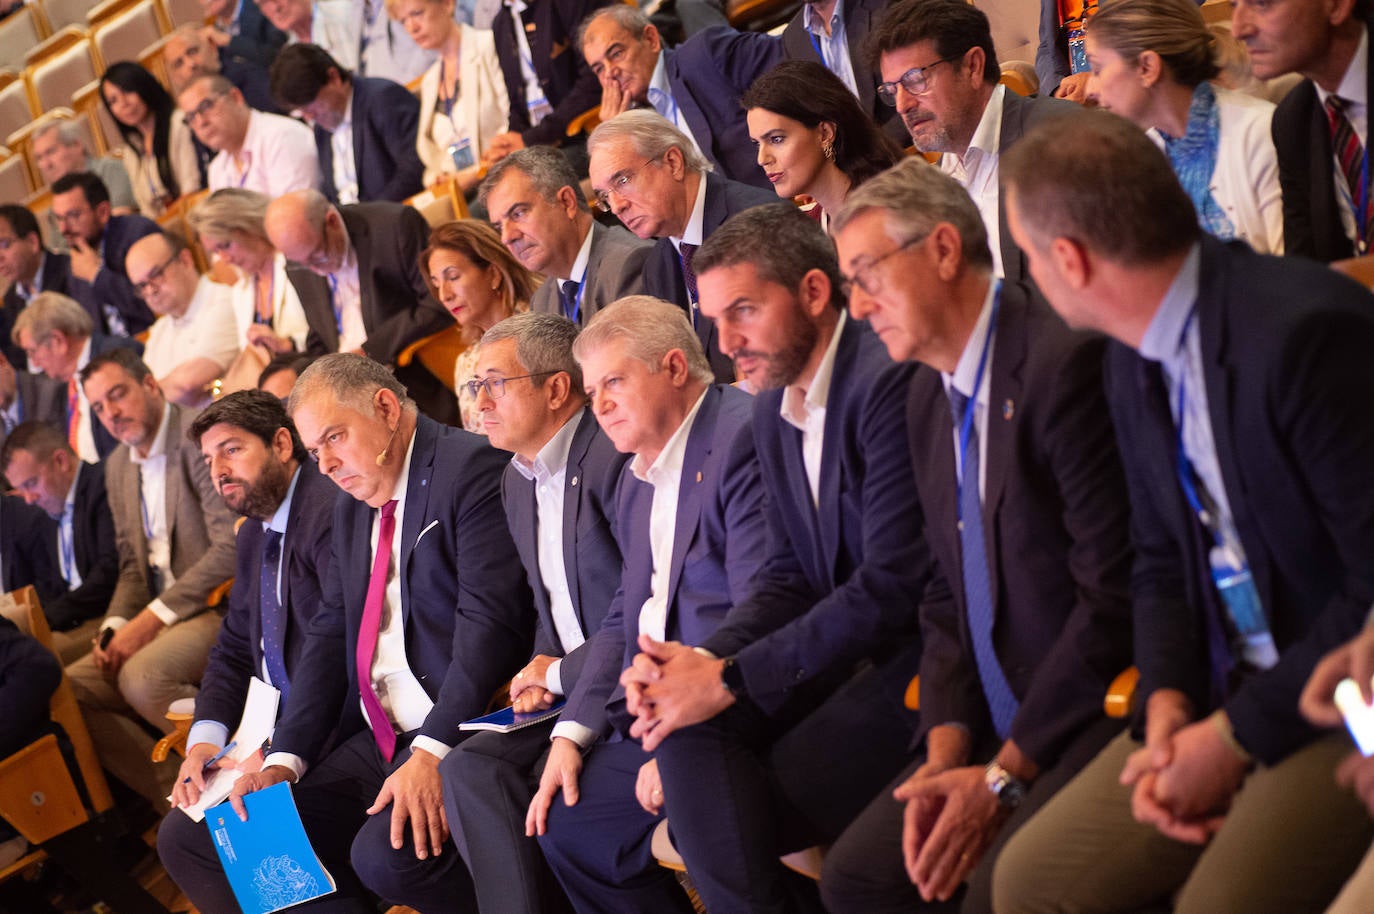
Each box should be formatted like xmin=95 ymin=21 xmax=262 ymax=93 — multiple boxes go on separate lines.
xmin=655 ymin=645 xmax=919 ymax=914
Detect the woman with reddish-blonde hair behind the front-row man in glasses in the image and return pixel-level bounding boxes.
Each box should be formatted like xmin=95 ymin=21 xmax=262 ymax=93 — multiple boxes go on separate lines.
xmin=420 ymin=219 xmax=540 ymax=434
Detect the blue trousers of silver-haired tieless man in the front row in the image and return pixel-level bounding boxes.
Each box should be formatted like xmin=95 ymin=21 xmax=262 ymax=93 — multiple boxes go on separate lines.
xmin=539 ymin=739 xmax=692 ymax=914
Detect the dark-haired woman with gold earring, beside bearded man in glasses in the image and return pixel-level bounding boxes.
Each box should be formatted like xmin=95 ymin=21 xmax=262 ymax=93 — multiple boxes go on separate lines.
xmin=739 ymin=60 xmax=901 ymax=225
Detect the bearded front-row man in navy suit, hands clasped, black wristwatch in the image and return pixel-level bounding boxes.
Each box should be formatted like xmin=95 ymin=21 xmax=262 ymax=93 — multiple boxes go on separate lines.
xmin=612 ymin=202 xmax=930 ymax=911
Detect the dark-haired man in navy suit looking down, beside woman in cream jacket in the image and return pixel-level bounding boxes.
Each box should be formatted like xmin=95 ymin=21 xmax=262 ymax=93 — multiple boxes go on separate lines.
xmin=272 ymin=44 xmax=425 ymax=203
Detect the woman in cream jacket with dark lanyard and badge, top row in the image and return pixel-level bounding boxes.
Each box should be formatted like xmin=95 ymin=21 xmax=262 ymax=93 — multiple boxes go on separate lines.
xmin=386 ymin=0 xmax=510 ymax=192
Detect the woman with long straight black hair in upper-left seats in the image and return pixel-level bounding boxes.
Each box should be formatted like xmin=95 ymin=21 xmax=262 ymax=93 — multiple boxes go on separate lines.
xmin=100 ymin=60 xmax=202 ymax=219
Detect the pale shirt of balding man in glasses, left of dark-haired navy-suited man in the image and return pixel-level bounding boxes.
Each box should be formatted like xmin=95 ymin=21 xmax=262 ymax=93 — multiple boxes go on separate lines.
xmin=207 ymin=110 xmax=320 ymax=197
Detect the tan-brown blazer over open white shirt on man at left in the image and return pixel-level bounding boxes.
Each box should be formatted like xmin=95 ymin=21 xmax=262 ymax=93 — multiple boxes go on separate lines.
xmin=104 ymin=404 xmax=235 ymax=618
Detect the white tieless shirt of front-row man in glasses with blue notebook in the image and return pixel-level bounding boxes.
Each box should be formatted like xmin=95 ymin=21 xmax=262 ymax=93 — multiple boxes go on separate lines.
xmin=511 ymin=408 xmax=587 ymax=695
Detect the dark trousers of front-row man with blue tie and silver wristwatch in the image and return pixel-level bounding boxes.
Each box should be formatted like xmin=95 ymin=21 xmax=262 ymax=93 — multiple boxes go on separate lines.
xmin=820 ymin=717 xmax=1123 ymax=914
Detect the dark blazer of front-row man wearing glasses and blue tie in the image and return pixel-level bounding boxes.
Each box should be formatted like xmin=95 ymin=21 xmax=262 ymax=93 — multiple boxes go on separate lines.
xmin=907 ymin=283 xmax=1131 ymax=768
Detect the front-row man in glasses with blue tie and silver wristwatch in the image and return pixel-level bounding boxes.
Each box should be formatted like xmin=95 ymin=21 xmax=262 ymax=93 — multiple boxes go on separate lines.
xmin=822 ymin=161 xmax=1131 ymax=913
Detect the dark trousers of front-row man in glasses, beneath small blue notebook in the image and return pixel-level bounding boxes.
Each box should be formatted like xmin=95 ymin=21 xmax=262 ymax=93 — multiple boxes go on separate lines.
xmin=440 ymin=720 xmax=570 ymax=914
